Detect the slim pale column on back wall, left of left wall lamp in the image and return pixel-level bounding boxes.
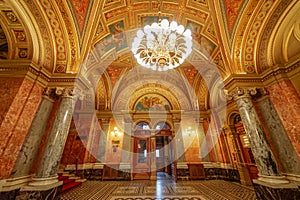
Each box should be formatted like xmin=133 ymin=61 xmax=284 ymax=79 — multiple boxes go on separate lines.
xmin=97 ymin=119 xmax=110 ymax=163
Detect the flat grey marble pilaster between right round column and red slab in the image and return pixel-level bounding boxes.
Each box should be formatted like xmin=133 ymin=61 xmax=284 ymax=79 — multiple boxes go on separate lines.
xmin=258 ymin=93 xmax=300 ymax=175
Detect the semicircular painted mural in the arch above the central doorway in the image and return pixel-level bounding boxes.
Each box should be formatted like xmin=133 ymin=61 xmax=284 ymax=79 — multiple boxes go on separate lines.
xmin=134 ymin=94 xmax=170 ymax=111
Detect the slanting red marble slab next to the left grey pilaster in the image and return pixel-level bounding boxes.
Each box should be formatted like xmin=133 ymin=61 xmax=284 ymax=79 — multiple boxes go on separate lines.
xmin=0 ymin=79 xmax=43 ymax=178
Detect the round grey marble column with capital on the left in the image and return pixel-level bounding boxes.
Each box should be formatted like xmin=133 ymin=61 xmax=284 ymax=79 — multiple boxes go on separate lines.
xmin=29 ymin=88 xmax=74 ymax=186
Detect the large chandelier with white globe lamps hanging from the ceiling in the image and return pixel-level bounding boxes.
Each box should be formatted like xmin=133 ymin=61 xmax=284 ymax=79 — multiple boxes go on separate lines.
xmin=131 ymin=19 xmax=192 ymax=71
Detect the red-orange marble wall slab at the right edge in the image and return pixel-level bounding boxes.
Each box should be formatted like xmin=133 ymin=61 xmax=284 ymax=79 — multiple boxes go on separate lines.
xmin=268 ymin=80 xmax=300 ymax=158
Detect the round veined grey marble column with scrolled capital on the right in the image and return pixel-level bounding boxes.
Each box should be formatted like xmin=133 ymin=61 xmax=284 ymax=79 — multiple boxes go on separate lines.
xmin=230 ymin=88 xmax=288 ymax=183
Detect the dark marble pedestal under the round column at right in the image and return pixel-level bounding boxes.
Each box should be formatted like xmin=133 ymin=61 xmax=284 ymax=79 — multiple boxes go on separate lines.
xmin=253 ymin=180 xmax=300 ymax=200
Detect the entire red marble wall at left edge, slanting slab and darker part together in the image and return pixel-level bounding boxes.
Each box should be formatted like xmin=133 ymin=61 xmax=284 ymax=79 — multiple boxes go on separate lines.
xmin=0 ymin=78 xmax=43 ymax=179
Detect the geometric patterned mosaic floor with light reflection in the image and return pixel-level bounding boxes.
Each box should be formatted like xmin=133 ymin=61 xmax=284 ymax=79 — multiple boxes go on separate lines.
xmin=61 ymin=180 xmax=256 ymax=200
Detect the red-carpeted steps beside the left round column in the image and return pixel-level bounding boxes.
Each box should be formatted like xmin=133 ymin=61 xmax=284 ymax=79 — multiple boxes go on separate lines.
xmin=58 ymin=172 xmax=86 ymax=192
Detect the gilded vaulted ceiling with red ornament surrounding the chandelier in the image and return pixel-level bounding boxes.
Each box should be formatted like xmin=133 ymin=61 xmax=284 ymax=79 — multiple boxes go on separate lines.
xmin=0 ymin=0 xmax=300 ymax=111
